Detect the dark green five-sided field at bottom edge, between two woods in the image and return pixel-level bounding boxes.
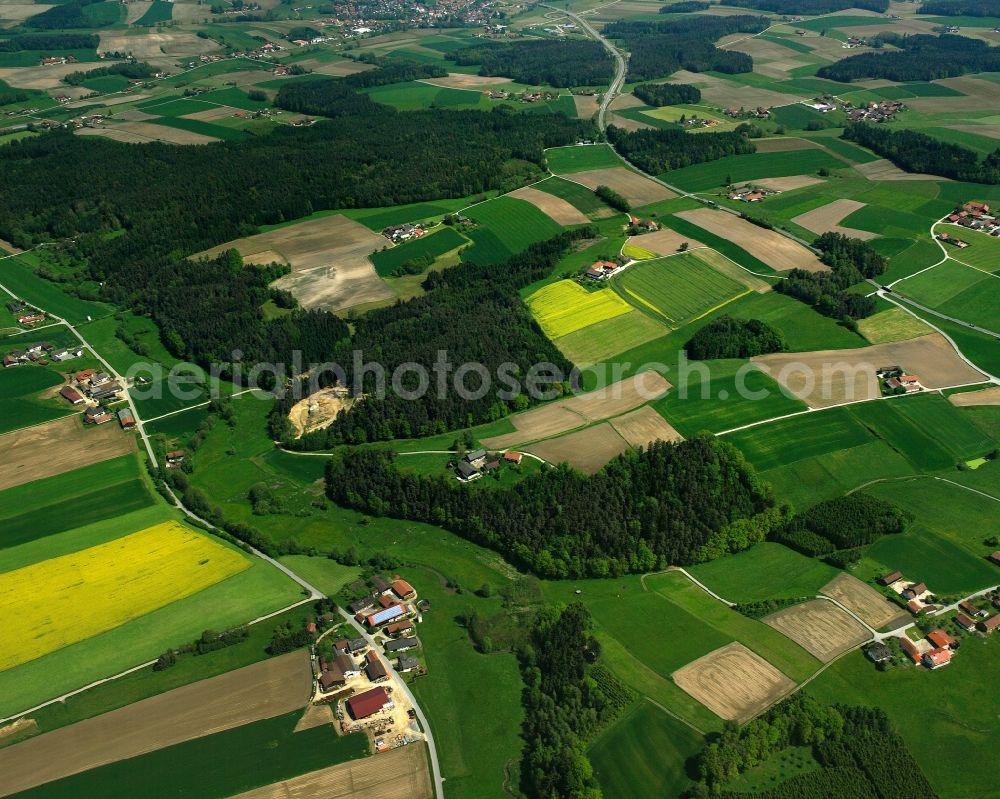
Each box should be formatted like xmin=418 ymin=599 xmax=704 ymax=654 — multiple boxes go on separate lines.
xmin=589 ymin=700 xmax=704 ymax=799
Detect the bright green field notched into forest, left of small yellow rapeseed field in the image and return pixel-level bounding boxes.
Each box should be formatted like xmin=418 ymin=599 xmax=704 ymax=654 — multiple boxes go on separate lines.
xmin=462 ymin=197 xmax=562 ymax=264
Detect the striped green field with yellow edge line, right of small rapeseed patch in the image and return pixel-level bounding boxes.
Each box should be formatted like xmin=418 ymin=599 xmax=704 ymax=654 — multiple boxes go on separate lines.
xmin=612 ymin=253 xmax=749 ymax=327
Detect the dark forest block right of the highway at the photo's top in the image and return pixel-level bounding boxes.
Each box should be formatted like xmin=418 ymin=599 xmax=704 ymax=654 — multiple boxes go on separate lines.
xmin=603 ymin=15 xmax=771 ymax=82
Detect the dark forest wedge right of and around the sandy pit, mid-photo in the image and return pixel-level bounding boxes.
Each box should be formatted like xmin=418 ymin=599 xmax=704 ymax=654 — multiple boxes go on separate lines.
xmin=271 ymin=227 xmax=597 ymax=450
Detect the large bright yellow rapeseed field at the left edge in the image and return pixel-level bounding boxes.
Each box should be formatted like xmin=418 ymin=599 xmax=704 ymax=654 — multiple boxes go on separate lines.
xmin=0 ymin=522 xmax=250 ymax=671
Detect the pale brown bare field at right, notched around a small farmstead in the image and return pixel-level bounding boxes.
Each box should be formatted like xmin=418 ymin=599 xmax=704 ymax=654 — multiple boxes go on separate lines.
xmin=751 ymin=333 xmax=985 ymax=408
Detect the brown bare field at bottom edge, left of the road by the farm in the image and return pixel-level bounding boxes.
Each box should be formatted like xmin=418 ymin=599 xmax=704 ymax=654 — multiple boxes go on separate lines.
xmin=233 ymin=743 xmax=434 ymax=799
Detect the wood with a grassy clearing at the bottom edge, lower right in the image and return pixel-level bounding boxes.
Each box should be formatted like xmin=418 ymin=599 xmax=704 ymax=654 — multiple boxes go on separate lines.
xmin=684 ymin=693 xmax=937 ymax=799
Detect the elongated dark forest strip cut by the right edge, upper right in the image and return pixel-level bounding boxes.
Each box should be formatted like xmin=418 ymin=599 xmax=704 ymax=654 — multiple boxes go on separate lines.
xmin=843 ymin=122 xmax=1000 ymax=183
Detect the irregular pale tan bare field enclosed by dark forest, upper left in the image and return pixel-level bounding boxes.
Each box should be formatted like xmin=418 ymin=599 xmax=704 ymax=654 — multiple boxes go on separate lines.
xmin=201 ymin=215 xmax=395 ymax=310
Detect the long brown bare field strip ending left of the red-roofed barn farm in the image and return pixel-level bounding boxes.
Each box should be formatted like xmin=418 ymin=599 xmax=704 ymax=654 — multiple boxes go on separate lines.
xmin=0 ymin=649 xmax=312 ymax=796
